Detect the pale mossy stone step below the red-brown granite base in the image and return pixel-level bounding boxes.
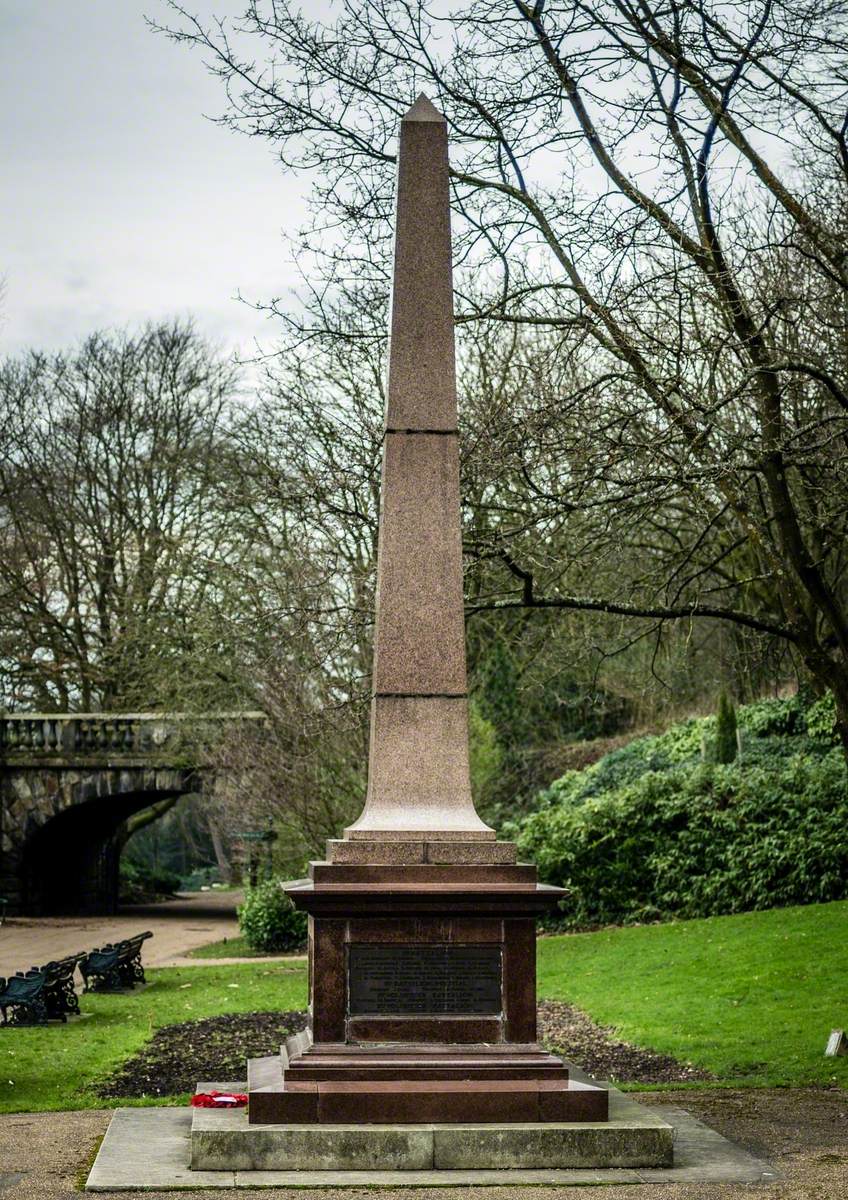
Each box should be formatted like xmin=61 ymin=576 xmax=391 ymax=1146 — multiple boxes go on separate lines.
xmin=191 ymin=1085 xmax=674 ymax=1171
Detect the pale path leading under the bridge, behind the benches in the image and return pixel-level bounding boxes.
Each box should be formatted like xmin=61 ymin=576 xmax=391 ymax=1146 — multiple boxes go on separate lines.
xmin=0 ymin=892 xmax=241 ymax=977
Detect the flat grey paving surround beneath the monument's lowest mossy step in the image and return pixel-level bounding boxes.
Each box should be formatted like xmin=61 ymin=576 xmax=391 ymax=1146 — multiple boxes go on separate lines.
xmin=86 ymin=1097 xmax=778 ymax=1192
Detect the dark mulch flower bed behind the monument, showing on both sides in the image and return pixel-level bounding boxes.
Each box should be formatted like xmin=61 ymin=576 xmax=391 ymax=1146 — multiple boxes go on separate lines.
xmin=97 ymin=1000 xmax=712 ymax=1099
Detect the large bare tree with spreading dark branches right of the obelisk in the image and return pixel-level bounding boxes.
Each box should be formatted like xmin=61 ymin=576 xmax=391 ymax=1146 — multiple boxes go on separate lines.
xmin=157 ymin=0 xmax=848 ymax=750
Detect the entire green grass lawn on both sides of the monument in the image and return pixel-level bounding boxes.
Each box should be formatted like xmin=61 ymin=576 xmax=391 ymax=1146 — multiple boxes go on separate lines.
xmin=0 ymin=901 xmax=848 ymax=1112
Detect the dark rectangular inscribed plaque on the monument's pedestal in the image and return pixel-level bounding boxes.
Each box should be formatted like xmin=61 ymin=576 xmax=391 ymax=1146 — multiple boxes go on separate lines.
xmin=348 ymin=943 xmax=503 ymax=1016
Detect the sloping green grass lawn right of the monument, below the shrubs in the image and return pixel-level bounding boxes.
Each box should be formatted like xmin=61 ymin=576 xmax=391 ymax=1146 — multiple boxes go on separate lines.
xmin=539 ymin=901 xmax=848 ymax=1087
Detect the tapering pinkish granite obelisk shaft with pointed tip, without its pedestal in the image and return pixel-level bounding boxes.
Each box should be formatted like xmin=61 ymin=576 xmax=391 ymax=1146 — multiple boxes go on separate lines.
xmin=345 ymin=96 xmax=494 ymax=841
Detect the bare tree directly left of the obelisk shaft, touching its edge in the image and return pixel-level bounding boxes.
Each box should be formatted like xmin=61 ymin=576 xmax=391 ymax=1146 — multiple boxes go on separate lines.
xmin=194 ymin=296 xmax=381 ymax=872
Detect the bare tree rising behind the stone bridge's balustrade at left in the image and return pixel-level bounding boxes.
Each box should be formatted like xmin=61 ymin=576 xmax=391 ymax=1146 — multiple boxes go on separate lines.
xmin=0 ymin=324 xmax=245 ymax=710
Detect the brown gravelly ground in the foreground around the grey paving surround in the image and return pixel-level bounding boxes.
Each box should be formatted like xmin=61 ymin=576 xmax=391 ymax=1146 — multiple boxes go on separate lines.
xmin=0 ymin=1088 xmax=848 ymax=1200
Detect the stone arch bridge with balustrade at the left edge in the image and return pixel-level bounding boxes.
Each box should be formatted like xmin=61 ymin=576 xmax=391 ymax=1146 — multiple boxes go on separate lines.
xmin=0 ymin=713 xmax=263 ymax=914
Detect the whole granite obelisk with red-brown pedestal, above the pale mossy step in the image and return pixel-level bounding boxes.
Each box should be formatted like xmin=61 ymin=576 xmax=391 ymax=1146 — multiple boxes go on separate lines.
xmin=242 ymin=96 xmax=608 ymax=1126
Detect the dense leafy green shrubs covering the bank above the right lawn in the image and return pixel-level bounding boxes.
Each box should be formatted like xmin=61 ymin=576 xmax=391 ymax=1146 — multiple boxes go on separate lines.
xmin=512 ymin=697 xmax=848 ymax=928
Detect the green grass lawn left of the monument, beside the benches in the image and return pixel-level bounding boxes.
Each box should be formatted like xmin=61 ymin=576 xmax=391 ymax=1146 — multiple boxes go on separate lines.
xmin=0 ymin=961 xmax=306 ymax=1112
